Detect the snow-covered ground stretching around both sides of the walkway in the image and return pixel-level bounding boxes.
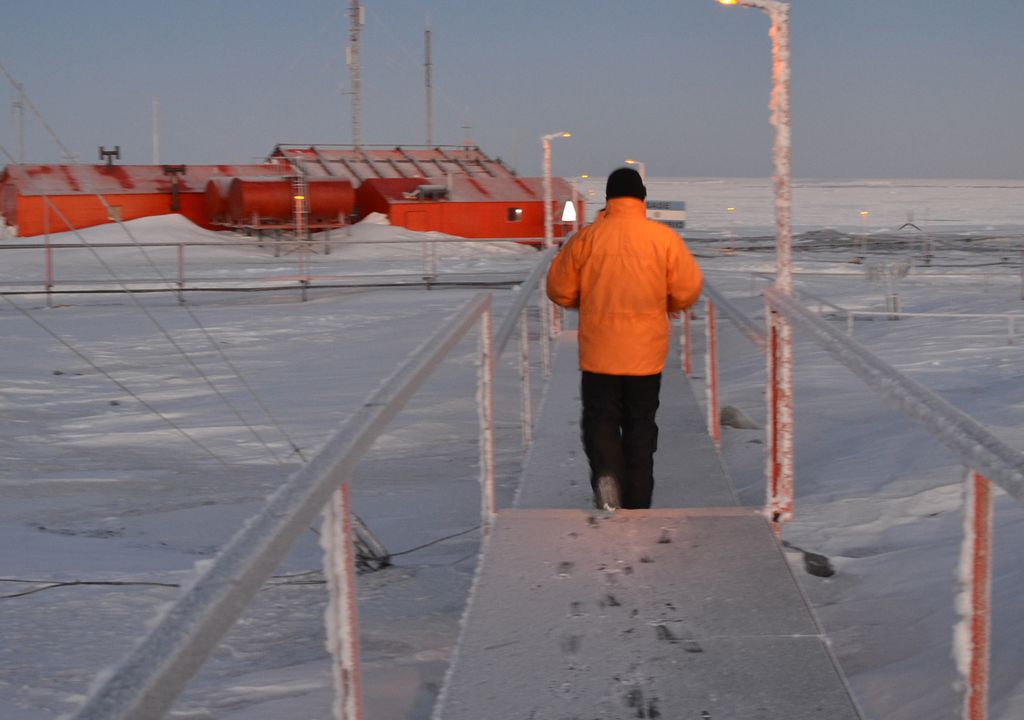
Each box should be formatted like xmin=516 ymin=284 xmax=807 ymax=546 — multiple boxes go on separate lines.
xmin=0 ymin=178 xmax=1024 ymax=720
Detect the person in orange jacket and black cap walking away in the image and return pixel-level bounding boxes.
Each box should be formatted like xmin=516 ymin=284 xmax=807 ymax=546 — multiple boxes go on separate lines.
xmin=547 ymin=168 xmax=702 ymax=510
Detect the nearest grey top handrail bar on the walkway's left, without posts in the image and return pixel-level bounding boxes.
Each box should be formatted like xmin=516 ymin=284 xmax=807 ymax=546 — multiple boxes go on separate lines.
xmin=73 ymin=293 xmax=490 ymax=720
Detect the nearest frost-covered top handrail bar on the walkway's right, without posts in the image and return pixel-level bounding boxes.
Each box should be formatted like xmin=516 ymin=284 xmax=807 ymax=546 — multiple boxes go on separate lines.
xmin=765 ymin=288 xmax=1024 ymax=505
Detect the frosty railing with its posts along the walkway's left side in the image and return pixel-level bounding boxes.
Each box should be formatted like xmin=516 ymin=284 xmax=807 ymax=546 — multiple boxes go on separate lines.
xmin=73 ymin=251 xmax=553 ymax=720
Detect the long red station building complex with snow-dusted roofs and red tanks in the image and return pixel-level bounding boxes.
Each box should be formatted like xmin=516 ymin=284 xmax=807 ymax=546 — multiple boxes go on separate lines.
xmin=0 ymin=145 xmax=583 ymax=238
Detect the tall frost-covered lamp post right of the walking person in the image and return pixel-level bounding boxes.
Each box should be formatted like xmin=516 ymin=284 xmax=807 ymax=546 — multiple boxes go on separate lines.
xmin=719 ymin=0 xmax=793 ymax=525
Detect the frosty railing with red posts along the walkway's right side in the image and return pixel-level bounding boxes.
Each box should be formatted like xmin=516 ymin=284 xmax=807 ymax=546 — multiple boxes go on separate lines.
xmin=685 ymin=285 xmax=1024 ymax=720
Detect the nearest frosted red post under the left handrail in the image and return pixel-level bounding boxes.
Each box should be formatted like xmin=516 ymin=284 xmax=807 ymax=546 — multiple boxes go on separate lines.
xmin=321 ymin=481 xmax=362 ymax=720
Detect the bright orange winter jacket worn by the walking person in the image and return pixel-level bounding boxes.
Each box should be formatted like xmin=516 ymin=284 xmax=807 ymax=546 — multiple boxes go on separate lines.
xmin=548 ymin=198 xmax=702 ymax=375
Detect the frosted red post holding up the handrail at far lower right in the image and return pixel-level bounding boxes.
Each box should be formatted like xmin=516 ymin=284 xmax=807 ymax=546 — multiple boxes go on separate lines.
xmin=953 ymin=472 xmax=992 ymax=720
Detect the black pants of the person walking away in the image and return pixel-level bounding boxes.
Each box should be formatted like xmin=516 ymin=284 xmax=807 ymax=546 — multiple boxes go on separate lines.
xmin=581 ymin=371 xmax=662 ymax=509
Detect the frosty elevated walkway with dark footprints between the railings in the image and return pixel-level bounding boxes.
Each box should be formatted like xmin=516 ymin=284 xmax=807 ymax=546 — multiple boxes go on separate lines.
xmin=435 ymin=333 xmax=860 ymax=720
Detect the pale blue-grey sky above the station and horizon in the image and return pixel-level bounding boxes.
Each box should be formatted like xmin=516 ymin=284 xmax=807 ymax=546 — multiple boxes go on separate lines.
xmin=0 ymin=0 xmax=1024 ymax=178
